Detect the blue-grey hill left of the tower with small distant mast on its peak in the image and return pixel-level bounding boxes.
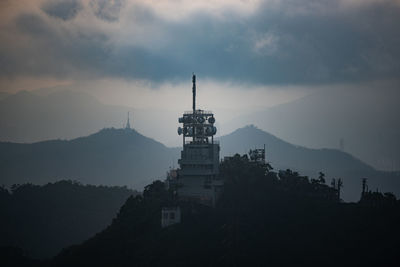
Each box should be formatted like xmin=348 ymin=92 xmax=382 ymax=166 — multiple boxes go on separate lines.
xmin=0 ymin=128 xmax=179 ymax=190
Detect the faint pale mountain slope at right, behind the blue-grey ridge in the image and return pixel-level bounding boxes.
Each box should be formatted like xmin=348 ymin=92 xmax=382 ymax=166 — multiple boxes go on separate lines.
xmin=225 ymin=84 xmax=400 ymax=171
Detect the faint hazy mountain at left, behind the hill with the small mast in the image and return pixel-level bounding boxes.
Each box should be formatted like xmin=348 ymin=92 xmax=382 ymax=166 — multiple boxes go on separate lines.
xmin=0 ymin=89 xmax=179 ymax=148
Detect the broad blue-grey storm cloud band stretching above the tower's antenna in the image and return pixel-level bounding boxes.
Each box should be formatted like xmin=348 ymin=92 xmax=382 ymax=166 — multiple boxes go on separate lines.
xmin=2 ymin=0 xmax=400 ymax=84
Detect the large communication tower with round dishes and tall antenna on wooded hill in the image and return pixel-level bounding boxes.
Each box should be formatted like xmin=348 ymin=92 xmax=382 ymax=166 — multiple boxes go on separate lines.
xmin=169 ymin=74 xmax=223 ymax=206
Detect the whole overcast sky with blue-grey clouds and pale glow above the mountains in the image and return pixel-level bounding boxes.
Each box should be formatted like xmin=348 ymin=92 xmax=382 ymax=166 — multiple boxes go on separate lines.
xmin=0 ymin=0 xmax=400 ymax=120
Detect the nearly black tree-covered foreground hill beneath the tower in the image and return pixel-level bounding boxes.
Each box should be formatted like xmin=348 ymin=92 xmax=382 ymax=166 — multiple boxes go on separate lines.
xmin=49 ymin=155 xmax=400 ymax=266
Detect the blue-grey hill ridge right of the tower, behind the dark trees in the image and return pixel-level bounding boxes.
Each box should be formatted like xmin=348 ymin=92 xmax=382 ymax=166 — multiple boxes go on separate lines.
xmin=220 ymin=126 xmax=400 ymax=201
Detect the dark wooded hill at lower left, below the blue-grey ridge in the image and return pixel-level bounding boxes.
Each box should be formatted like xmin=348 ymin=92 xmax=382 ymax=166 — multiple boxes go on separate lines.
xmin=0 ymin=181 xmax=137 ymax=258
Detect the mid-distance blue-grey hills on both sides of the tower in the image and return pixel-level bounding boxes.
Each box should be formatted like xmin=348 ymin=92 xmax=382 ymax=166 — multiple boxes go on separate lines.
xmin=0 ymin=126 xmax=400 ymax=201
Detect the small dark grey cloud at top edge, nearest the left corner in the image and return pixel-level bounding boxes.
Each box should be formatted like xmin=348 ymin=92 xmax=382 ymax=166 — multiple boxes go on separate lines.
xmin=42 ymin=0 xmax=82 ymax=20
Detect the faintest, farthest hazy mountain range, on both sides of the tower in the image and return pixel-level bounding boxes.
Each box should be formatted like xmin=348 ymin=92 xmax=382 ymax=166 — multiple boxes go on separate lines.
xmin=0 ymin=88 xmax=400 ymax=171
